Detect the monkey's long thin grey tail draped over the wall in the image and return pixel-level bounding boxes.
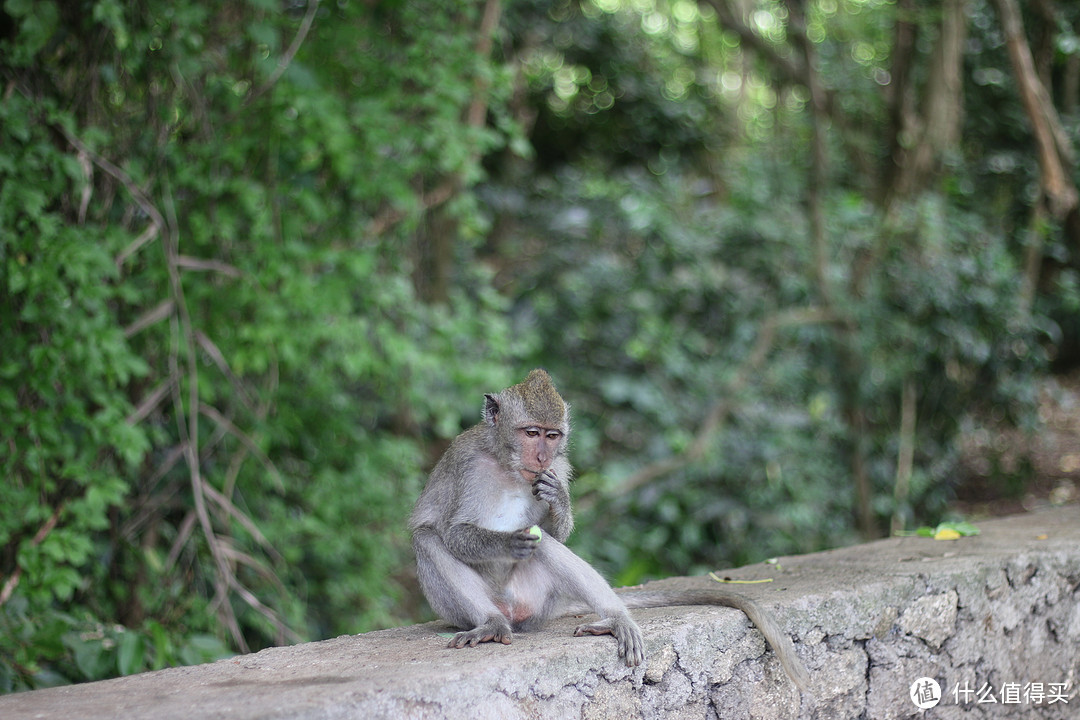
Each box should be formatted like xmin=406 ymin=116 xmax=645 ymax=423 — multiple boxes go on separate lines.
xmin=616 ymin=587 xmax=810 ymax=693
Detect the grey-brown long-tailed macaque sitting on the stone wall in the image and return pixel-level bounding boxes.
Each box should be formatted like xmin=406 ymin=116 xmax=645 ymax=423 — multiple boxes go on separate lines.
xmin=409 ymin=370 xmax=809 ymax=690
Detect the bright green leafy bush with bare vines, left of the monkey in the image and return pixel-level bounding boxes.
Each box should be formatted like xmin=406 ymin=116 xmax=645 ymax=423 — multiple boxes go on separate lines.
xmin=0 ymin=0 xmax=514 ymax=690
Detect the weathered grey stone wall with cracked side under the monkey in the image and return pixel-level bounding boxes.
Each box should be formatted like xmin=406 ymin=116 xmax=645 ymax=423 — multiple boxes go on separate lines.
xmin=0 ymin=506 xmax=1080 ymax=720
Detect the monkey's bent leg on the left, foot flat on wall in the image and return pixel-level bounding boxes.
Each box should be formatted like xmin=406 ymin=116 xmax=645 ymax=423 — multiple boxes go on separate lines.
xmin=413 ymin=528 xmax=513 ymax=648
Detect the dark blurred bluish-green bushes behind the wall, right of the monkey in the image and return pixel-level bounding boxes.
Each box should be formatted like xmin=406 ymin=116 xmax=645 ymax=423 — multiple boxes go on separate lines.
xmin=501 ymin=165 xmax=1044 ymax=583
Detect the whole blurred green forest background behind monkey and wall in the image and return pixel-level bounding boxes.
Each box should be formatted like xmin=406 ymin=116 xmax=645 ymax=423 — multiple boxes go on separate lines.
xmin=0 ymin=0 xmax=1080 ymax=691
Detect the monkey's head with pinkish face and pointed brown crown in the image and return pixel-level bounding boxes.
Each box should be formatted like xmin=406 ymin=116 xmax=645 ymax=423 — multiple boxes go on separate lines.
xmin=484 ymin=369 xmax=570 ymax=480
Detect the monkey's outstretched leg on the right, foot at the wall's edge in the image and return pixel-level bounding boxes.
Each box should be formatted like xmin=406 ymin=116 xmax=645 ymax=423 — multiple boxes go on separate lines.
xmin=541 ymin=542 xmax=645 ymax=667
